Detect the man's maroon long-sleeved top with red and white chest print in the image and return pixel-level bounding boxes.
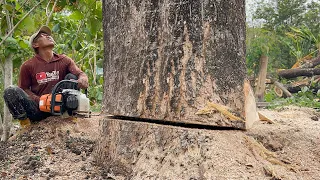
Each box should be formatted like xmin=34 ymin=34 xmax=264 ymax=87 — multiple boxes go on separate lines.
xmin=18 ymin=54 xmax=87 ymax=103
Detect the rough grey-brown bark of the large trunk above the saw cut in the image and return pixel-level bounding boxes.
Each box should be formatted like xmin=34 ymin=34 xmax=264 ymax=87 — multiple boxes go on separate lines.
xmin=103 ymin=0 xmax=252 ymax=128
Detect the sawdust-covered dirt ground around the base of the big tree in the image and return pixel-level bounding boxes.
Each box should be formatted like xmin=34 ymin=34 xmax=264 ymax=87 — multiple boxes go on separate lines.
xmin=0 ymin=106 xmax=320 ymax=180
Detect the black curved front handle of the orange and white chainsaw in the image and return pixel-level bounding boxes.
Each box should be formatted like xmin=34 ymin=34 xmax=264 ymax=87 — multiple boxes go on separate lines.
xmin=51 ymin=80 xmax=78 ymax=115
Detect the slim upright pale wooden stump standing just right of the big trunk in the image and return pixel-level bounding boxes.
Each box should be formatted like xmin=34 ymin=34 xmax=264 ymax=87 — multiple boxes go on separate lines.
xmin=255 ymin=55 xmax=268 ymax=101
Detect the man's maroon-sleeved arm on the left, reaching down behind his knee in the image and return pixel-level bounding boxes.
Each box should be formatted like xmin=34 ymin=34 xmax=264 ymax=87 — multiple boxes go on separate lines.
xmin=18 ymin=64 xmax=40 ymax=103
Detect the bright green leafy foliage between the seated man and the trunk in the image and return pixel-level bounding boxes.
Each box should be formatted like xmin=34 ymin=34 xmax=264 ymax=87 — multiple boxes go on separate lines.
xmin=51 ymin=0 xmax=103 ymax=110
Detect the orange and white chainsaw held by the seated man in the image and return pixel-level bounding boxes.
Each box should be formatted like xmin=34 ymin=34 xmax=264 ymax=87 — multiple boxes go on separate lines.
xmin=39 ymin=80 xmax=91 ymax=117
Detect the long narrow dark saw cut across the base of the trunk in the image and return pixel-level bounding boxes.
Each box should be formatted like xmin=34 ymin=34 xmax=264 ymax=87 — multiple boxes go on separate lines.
xmin=106 ymin=115 xmax=243 ymax=130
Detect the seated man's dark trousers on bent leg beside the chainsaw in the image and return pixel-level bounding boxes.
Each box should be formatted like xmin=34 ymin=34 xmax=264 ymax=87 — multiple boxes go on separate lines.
xmin=3 ymin=74 xmax=78 ymax=121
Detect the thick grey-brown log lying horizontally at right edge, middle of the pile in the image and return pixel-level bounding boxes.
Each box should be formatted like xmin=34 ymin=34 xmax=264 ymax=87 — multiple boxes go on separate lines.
xmin=278 ymin=68 xmax=320 ymax=79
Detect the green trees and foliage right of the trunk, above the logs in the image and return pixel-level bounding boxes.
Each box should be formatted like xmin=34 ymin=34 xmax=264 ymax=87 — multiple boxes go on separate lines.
xmin=251 ymin=0 xmax=320 ymax=72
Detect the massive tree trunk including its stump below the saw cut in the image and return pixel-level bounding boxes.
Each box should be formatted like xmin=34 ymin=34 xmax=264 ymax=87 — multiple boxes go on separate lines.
xmin=95 ymin=0 xmax=258 ymax=179
